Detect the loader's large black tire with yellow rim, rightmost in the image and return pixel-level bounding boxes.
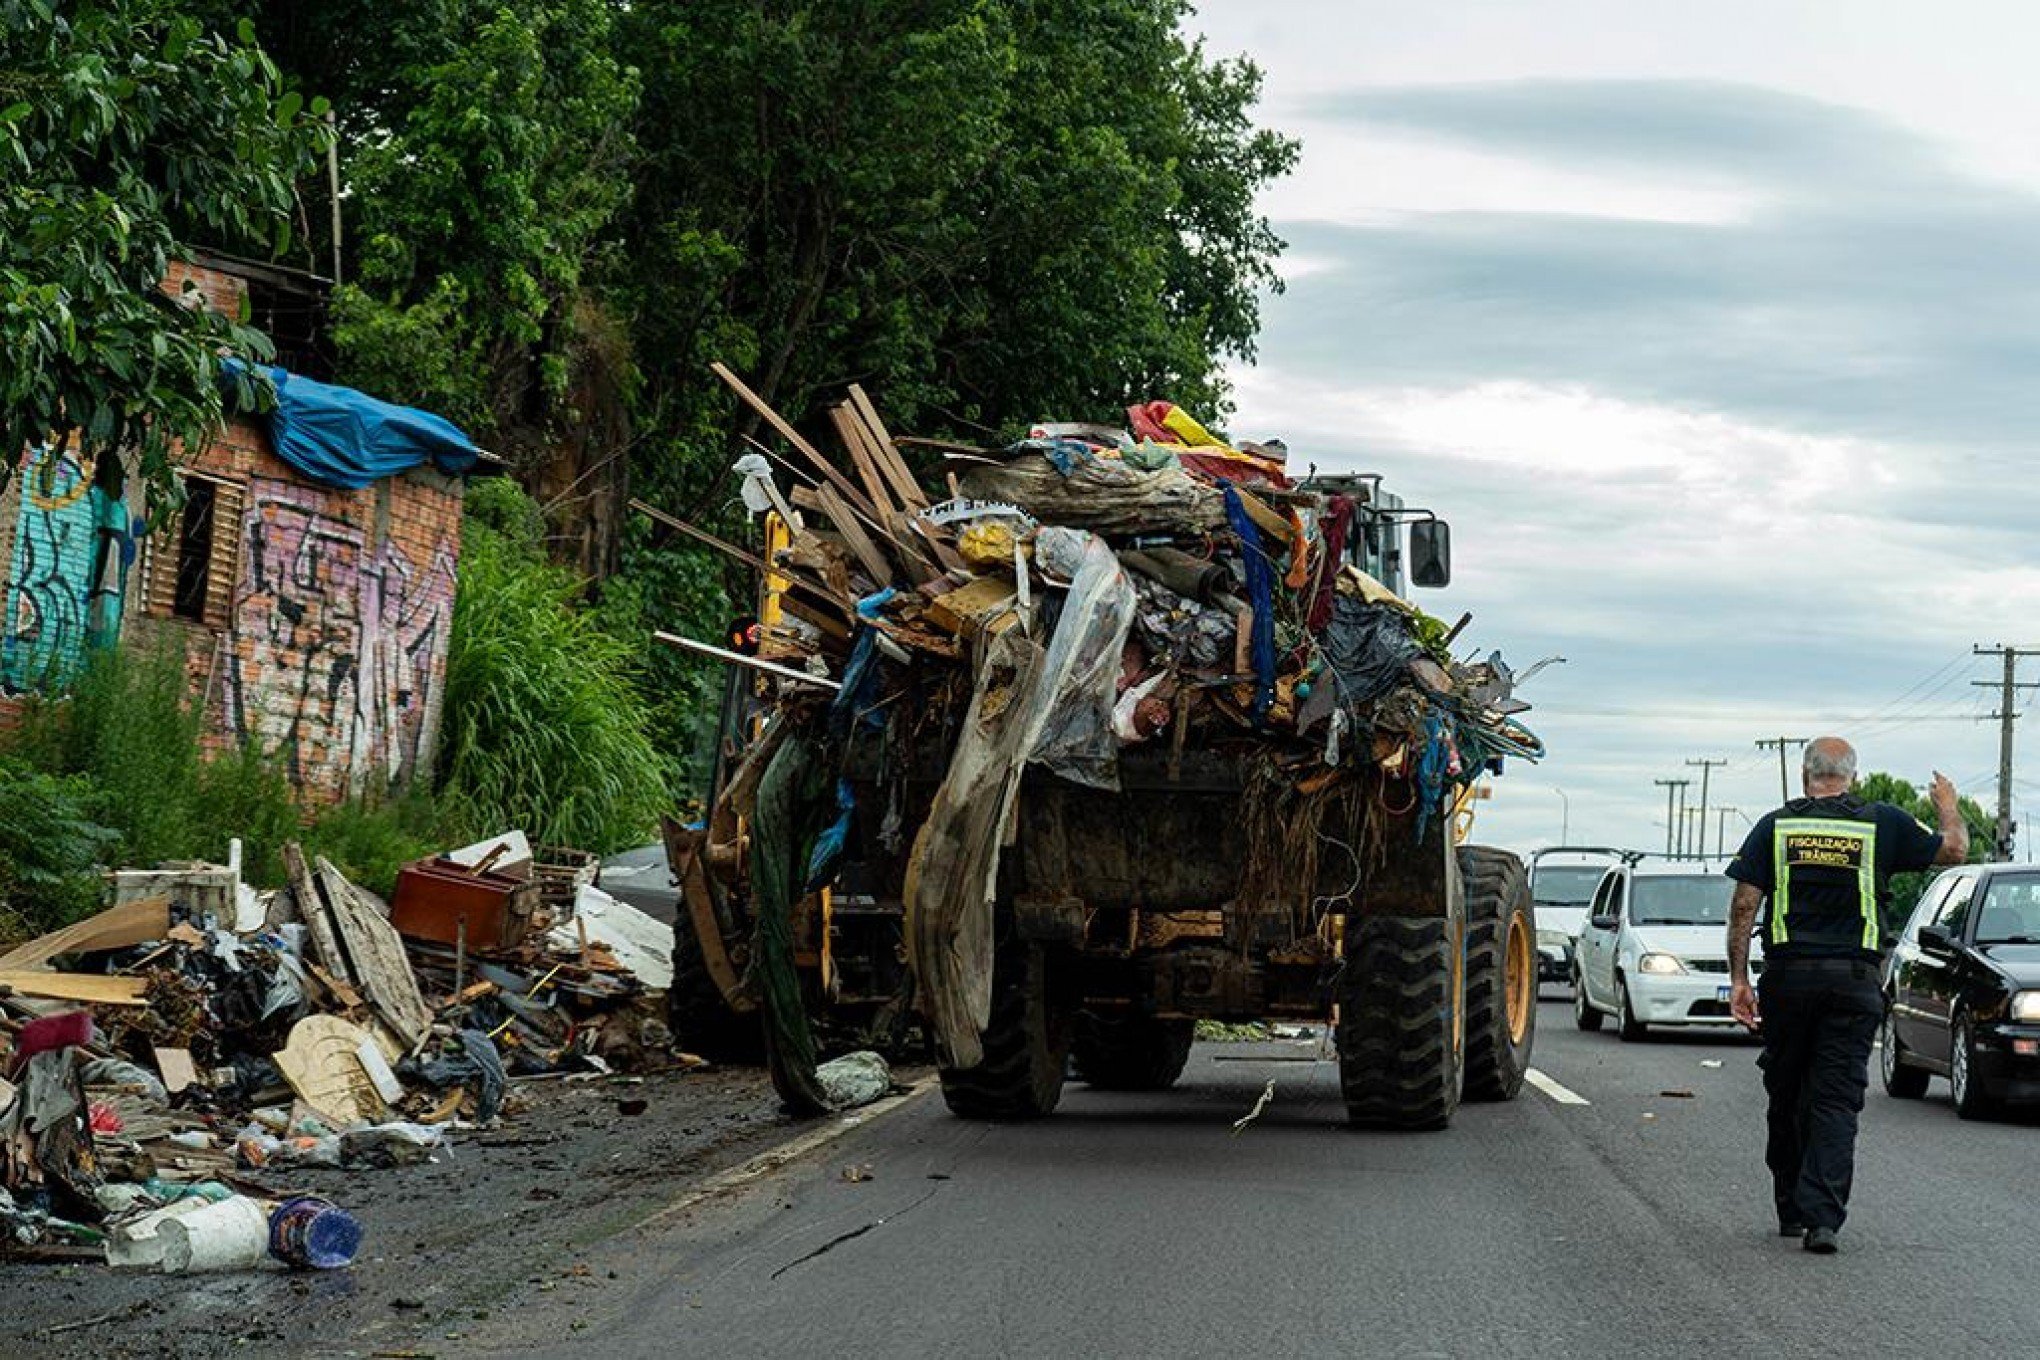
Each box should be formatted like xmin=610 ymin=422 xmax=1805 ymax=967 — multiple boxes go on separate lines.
xmin=1459 ymin=846 xmax=1536 ymax=1101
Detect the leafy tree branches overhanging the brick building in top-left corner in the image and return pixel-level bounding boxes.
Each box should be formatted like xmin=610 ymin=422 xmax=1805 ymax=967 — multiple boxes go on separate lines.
xmin=0 ymin=0 xmax=324 ymax=491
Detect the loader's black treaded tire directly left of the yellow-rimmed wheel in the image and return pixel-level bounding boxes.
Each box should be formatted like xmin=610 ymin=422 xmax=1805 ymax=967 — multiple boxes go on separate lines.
xmin=1338 ymin=911 xmax=1465 ymax=1130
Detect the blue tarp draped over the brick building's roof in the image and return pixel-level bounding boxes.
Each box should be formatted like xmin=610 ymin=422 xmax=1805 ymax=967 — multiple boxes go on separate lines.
xmin=226 ymin=359 xmax=481 ymax=491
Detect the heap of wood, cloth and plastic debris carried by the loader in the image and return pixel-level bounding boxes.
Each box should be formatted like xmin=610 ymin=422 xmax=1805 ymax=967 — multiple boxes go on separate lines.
xmin=639 ymin=367 xmax=1542 ymax=1109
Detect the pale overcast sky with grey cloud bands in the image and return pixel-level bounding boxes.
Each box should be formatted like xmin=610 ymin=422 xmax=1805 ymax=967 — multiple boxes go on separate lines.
xmin=1191 ymin=0 xmax=2040 ymax=856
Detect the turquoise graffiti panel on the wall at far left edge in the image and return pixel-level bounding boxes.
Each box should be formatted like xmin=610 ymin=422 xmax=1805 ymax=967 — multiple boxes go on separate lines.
xmin=0 ymin=447 xmax=133 ymax=689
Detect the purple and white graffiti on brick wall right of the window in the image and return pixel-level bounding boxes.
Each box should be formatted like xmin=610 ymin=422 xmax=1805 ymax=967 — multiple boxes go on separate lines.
xmin=226 ymin=477 xmax=453 ymax=793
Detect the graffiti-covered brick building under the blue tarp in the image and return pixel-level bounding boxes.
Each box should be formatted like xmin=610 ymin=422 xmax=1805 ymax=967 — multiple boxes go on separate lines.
xmin=0 ymin=257 xmax=463 ymax=801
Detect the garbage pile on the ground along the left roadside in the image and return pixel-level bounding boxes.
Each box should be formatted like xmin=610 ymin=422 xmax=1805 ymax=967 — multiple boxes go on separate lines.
xmin=0 ymin=832 xmax=677 ymax=1272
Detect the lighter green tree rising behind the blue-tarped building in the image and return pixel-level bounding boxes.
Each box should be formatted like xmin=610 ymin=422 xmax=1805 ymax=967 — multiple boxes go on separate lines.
xmin=335 ymin=0 xmax=636 ymax=434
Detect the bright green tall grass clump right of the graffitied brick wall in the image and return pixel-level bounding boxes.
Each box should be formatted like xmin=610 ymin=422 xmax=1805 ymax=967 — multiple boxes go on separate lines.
xmin=439 ymin=481 xmax=667 ymax=852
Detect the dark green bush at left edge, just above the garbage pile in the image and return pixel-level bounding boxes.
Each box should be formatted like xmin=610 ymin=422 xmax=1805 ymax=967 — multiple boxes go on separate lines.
xmin=0 ymin=756 xmax=114 ymax=938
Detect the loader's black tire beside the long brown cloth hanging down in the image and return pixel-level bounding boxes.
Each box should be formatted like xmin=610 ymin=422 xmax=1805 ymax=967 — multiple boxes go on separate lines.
xmin=938 ymin=940 xmax=1073 ymax=1119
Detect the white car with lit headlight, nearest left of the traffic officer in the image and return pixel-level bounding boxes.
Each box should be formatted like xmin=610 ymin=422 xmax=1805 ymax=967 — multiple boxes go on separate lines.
xmin=1573 ymin=858 xmax=1763 ymax=1040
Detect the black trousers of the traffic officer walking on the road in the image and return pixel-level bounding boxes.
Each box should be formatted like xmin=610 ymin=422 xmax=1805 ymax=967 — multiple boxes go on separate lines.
xmin=1756 ymin=958 xmax=1885 ymax=1227
